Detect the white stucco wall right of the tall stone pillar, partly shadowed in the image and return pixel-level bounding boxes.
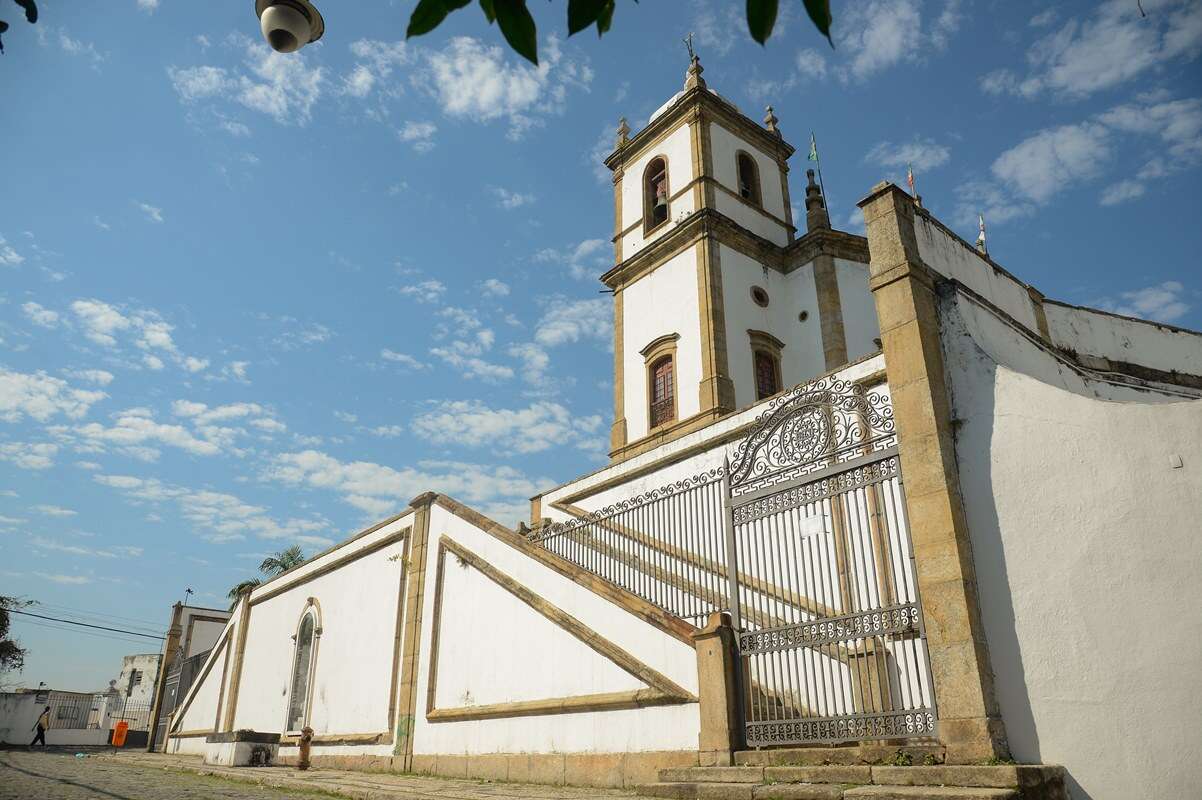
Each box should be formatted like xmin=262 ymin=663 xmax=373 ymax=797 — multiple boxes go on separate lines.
xmin=945 ymin=293 xmax=1202 ymax=800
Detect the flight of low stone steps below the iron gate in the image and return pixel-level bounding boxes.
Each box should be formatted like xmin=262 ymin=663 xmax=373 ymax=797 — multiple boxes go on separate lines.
xmin=638 ymin=747 xmax=1069 ymax=800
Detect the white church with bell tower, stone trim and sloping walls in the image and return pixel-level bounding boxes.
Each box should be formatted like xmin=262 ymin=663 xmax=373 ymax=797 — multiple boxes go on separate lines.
xmin=167 ymin=61 xmax=1202 ymax=800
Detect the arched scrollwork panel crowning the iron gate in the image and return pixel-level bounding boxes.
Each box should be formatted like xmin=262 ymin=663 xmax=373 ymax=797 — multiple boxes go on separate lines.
xmin=728 ymin=376 xmax=895 ymax=495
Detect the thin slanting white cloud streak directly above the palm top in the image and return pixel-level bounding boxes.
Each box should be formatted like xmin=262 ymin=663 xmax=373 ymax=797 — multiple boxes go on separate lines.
xmin=93 ymin=474 xmax=332 ymax=545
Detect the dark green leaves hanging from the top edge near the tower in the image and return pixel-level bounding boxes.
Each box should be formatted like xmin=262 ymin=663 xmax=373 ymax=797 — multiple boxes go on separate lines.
xmin=405 ymin=0 xmax=834 ymax=64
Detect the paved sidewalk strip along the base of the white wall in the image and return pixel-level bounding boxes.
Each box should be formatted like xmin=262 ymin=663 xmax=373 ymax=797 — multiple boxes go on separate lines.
xmin=98 ymin=751 xmax=638 ymax=800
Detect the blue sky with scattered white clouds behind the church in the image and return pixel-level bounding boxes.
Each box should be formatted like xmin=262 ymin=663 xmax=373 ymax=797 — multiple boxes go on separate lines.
xmin=0 ymin=0 xmax=1202 ymax=689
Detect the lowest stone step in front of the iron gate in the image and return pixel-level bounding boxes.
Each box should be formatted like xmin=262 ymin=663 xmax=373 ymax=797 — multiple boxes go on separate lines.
xmin=637 ymin=781 xmax=1022 ymax=800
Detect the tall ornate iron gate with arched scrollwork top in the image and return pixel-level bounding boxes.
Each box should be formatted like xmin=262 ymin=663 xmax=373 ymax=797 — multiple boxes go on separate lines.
xmin=725 ymin=377 xmax=936 ymax=747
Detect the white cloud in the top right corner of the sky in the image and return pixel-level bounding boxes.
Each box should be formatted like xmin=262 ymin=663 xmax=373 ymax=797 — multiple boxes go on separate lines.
xmin=981 ymin=0 xmax=1202 ymax=97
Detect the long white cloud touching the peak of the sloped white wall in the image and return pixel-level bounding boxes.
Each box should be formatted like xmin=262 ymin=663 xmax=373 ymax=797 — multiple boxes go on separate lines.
xmin=263 ymin=449 xmax=549 ymax=525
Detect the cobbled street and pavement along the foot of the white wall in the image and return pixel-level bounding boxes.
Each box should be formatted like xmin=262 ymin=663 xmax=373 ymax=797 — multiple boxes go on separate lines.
xmin=0 ymin=748 xmax=649 ymax=800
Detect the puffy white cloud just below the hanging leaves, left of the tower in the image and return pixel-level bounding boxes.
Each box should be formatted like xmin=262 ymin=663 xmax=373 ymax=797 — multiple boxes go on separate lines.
xmin=424 ymin=36 xmax=593 ymax=139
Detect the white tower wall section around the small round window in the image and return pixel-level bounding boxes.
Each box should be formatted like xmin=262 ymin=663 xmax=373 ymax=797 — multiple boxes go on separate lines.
xmin=719 ymin=245 xmax=831 ymax=407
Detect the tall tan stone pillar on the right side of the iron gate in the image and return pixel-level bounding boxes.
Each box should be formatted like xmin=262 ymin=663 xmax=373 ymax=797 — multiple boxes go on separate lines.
xmin=859 ymin=183 xmax=1008 ymax=763
